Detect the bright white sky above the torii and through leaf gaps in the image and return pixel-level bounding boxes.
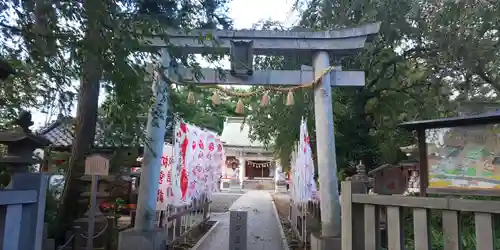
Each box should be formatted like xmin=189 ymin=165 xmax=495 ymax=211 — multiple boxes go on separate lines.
xmin=31 ymin=0 xmax=297 ymax=129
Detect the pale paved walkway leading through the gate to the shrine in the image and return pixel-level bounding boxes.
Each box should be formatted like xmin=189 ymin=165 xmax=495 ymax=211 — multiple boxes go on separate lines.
xmin=198 ymin=190 xmax=283 ymax=250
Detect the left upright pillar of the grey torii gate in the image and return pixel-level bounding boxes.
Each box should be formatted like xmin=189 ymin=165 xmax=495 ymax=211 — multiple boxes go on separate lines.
xmin=134 ymin=48 xmax=170 ymax=231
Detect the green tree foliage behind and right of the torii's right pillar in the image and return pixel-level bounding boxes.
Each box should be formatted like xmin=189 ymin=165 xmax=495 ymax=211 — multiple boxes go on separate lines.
xmin=250 ymin=0 xmax=500 ymax=174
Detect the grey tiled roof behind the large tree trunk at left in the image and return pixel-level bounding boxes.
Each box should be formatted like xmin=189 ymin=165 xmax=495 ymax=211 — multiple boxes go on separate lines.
xmin=36 ymin=117 xmax=172 ymax=147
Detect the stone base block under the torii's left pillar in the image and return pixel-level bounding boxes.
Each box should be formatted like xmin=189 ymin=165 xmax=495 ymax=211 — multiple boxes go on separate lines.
xmin=118 ymin=228 xmax=167 ymax=250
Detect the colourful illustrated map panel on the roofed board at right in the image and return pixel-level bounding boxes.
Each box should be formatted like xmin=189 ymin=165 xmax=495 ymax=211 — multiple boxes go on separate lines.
xmin=426 ymin=124 xmax=500 ymax=190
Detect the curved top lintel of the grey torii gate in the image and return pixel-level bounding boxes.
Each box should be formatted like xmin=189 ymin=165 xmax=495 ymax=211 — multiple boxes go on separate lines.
xmin=148 ymin=22 xmax=380 ymax=56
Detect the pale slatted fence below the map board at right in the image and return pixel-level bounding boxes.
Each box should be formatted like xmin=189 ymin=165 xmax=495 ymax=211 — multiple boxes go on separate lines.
xmin=341 ymin=181 xmax=500 ymax=250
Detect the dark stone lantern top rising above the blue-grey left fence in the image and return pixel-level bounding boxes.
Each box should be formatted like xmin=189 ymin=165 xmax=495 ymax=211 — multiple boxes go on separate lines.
xmin=0 ymin=111 xmax=50 ymax=186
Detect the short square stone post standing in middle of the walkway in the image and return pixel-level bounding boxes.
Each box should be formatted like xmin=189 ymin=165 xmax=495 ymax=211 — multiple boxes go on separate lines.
xmin=229 ymin=211 xmax=248 ymax=250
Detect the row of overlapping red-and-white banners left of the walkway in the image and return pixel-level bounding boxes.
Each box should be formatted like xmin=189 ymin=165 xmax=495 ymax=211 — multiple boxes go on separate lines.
xmin=156 ymin=122 xmax=225 ymax=207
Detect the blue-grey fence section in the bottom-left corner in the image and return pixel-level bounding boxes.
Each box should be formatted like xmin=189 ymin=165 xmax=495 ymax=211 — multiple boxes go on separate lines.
xmin=0 ymin=173 xmax=48 ymax=250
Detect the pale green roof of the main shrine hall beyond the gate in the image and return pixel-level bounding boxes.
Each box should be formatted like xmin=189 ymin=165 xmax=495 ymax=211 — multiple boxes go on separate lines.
xmin=220 ymin=117 xmax=265 ymax=148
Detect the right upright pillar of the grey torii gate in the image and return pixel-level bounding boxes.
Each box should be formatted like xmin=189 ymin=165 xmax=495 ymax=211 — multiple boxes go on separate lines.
xmin=313 ymin=51 xmax=341 ymax=237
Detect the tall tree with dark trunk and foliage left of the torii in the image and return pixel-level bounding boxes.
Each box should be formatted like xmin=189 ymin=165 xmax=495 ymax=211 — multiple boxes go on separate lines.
xmin=0 ymin=0 xmax=230 ymax=241
